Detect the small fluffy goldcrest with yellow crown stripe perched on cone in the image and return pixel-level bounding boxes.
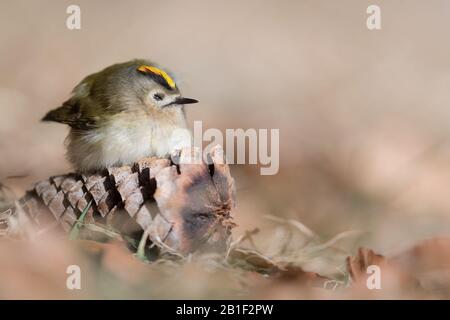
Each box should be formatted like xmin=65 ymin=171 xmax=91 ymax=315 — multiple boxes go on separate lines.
xmin=42 ymin=60 xmax=198 ymax=172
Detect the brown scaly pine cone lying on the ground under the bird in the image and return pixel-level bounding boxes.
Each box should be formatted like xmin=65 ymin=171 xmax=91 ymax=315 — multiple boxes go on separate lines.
xmin=5 ymin=147 xmax=235 ymax=254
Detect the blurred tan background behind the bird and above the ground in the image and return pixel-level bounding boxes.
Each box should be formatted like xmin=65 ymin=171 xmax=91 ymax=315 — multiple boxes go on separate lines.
xmin=0 ymin=0 xmax=450 ymax=253
